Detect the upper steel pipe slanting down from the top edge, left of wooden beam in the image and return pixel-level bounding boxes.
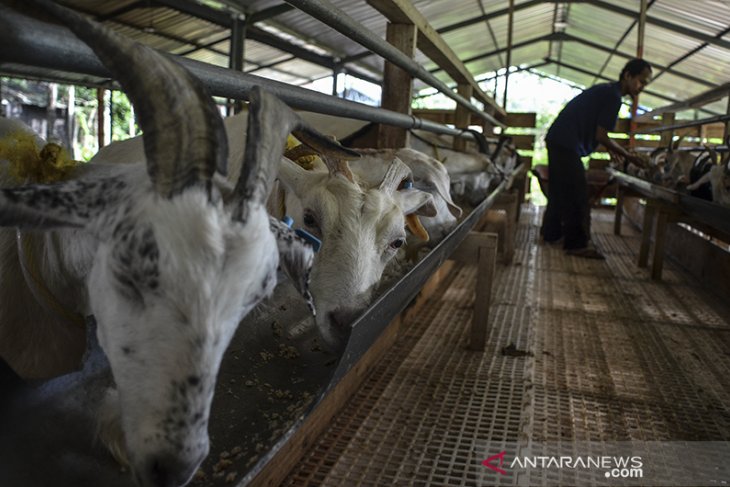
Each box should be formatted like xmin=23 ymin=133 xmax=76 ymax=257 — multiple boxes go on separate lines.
xmin=286 ymin=0 xmax=506 ymax=128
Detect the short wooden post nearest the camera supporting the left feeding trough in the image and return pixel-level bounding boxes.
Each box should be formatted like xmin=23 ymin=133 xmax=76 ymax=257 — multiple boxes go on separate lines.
xmin=449 ymin=232 xmax=498 ymax=351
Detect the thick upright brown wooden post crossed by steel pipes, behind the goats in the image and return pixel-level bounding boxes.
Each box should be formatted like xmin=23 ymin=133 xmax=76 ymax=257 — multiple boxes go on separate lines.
xmin=377 ymin=23 xmax=417 ymax=149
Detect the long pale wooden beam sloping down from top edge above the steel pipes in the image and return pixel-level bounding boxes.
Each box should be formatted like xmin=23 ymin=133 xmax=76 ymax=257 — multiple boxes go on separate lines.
xmin=367 ymin=0 xmax=506 ymax=116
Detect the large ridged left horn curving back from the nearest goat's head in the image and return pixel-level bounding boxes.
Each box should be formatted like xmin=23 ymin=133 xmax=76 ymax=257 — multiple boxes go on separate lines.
xmin=35 ymin=0 xmax=228 ymax=198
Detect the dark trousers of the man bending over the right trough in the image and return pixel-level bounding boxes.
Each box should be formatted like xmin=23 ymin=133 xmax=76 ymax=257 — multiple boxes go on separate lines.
xmin=542 ymin=144 xmax=591 ymax=250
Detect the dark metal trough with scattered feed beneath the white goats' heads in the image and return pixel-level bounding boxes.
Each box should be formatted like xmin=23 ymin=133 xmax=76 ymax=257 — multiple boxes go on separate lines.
xmin=0 ymin=168 xmax=520 ymax=487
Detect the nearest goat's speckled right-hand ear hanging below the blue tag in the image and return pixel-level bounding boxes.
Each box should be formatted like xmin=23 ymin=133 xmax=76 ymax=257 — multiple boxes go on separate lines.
xmin=269 ymin=217 xmax=315 ymax=315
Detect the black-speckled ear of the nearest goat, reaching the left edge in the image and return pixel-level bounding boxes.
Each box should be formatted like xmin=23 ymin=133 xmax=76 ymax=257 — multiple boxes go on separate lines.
xmin=0 ymin=179 xmax=125 ymax=229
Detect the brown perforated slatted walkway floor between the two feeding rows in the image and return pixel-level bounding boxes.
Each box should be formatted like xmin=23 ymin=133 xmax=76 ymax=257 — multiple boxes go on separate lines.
xmin=285 ymin=206 xmax=730 ymax=487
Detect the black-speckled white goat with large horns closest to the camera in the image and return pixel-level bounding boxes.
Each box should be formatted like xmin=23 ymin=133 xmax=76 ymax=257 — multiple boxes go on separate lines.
xmin=0 ymin=1 xmax=347 ymax=486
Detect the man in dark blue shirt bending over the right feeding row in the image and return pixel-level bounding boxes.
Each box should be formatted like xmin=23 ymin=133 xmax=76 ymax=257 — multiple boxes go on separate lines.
xmin=541 ymin=59 xmax=651 ymax=259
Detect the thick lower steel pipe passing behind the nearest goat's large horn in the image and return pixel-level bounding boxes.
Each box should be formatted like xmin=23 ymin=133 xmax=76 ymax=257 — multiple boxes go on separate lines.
xmin=0 ymin=5 xmax=494 ymax=140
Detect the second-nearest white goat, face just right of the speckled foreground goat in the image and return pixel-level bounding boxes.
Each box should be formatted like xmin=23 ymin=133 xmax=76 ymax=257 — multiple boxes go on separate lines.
xmin=95 ymin=112 xmax=436 ymax=350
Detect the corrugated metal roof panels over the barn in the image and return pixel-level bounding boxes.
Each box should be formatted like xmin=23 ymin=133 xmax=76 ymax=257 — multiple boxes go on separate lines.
xmin=5 ymin=0 xmax=730 ymax=119
